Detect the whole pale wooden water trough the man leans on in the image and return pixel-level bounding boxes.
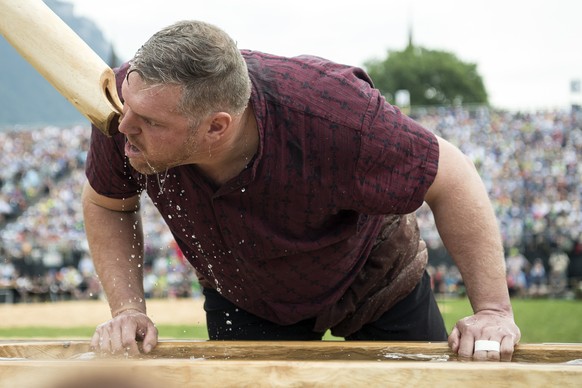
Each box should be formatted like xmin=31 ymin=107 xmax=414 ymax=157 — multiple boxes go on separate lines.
xmin=0 ymin=341 xmax=582 ymax=388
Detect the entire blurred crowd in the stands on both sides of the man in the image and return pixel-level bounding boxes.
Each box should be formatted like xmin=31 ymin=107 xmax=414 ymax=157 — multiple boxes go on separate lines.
xmin=0 ymin=108 xmax=582 ymax=302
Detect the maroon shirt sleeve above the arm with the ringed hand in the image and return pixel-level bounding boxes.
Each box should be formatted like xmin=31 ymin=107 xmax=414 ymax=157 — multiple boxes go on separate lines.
xmin=354 ymin=91 xmax=439 ymax=214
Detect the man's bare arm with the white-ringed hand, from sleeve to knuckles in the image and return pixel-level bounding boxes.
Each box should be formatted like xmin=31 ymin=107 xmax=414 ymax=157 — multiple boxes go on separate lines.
xmin=425 ymin=138 xmax=521 ymax=361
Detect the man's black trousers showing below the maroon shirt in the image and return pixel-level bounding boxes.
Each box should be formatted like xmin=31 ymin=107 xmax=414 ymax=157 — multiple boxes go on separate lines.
xmin=203 ymin=272 xmax=447 ymax=341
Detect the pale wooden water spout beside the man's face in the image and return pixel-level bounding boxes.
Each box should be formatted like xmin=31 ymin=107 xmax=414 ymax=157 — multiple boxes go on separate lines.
xmin=0 ymin=0 xmax=122 ymax=136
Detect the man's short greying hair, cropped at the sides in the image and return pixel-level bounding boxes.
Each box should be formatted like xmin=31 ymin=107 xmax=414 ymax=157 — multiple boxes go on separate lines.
xmin=130 ymin=21 xmax=251 ymax=123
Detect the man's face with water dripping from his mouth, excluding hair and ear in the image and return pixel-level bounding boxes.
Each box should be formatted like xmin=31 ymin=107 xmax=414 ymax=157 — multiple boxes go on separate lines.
xmin=119 ymin=72 xmax=203 ymax=174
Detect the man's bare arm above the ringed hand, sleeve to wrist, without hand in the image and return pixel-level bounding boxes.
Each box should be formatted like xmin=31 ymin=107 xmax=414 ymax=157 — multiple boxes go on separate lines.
xmin=427 ymin=138 xmax=511 ymax=313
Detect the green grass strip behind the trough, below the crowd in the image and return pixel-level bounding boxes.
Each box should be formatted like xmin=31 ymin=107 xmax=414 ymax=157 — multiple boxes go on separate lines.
xmin=0 ymin=299 xmax=582 ymax=343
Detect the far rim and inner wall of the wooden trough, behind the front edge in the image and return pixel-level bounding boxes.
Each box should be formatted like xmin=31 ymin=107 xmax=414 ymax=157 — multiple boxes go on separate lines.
xmin=0 ymin=340 xmax=582 ymax=363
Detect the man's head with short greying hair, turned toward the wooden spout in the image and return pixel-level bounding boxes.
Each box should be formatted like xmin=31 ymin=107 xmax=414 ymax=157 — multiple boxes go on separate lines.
xmin=119 ymin=21 xmax=251 ymax=174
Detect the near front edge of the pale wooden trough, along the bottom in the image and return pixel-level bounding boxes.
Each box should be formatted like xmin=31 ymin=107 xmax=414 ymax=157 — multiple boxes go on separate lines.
xmin=0 ymin=359 xmax=582 ymax=388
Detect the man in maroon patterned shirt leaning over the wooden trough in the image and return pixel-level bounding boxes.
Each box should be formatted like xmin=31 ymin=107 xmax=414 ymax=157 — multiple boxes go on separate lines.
xmin=83 ymin=21 xmax=520 ymax=360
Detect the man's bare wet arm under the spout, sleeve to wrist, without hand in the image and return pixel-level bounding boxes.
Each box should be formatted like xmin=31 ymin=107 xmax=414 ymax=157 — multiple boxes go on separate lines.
xmin=83 ymin=186 xmax=146 ymax=316
